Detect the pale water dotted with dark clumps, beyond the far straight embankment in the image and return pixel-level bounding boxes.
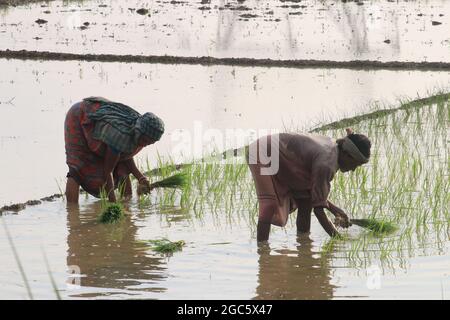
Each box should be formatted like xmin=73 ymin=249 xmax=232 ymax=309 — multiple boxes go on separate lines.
xmin=0 ymin=0 xmax=450 ymax=61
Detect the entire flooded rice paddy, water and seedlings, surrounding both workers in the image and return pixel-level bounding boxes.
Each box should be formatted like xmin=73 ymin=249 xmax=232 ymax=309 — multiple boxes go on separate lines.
xmin=0 ymin=0 xmax=450 ymax=299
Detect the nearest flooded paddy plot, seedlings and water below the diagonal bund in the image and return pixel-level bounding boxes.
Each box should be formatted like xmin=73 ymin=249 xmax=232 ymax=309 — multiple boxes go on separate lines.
xmin=0 ymin=95 xmax=450 ymax=299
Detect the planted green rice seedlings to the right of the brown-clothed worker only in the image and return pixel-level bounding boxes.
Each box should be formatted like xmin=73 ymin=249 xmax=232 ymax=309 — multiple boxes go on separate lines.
xmin=319 ymin=94 xmax=450 ymax=265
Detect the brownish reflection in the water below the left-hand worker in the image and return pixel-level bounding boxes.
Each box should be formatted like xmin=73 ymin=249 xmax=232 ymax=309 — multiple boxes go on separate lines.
xmin=67 ymin=202 xmax=165 ymax=296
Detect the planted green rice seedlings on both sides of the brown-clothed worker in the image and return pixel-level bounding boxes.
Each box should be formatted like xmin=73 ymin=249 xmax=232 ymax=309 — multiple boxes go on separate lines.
xmin=137 ymin=93 xmax=450 ymax=267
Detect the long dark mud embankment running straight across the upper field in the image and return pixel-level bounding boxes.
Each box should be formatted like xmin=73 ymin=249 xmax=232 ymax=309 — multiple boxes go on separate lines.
xmin=0 ymin=50 xmax=450 ymax=71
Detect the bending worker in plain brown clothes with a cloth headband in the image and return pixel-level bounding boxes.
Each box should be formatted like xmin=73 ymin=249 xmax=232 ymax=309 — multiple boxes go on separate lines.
xmin=248 ymin=129 xmax=371 ymax=241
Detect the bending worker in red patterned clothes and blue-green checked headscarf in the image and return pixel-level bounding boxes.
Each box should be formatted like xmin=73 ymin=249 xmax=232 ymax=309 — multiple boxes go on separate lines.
xmin=64 ymin=97 xmax=164 ymax=203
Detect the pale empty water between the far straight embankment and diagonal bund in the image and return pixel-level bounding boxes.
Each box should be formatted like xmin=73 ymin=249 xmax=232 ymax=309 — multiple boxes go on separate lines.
xmin=0 ymin=60 xmax=450 ymax=206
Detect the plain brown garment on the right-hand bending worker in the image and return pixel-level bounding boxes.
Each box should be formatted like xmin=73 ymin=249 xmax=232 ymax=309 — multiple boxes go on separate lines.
xmin=248 ymin=133 xmax=338 ymax=227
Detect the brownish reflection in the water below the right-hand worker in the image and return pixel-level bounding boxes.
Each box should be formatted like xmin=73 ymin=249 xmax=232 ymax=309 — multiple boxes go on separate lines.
xmin=254 ymin=235 xmax=335 ymax=299
